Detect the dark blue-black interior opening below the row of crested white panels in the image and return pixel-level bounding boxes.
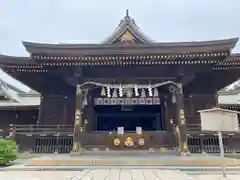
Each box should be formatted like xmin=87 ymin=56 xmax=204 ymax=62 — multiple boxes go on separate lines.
xmin=95 ymin=105 xmax=163 ymax=131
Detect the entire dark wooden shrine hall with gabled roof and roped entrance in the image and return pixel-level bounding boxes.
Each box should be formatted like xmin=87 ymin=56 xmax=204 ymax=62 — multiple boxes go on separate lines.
xmin=0 ymin=11 xmax=240 ymax=152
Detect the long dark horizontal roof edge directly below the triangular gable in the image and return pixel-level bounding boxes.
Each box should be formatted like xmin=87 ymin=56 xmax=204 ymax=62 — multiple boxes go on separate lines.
xmin=23 ymin=38 xmax=238 ymax=56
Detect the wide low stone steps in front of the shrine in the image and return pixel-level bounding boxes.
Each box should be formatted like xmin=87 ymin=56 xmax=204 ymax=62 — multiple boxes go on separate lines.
xmin=26 ymin=154 xmax=240 ymax=166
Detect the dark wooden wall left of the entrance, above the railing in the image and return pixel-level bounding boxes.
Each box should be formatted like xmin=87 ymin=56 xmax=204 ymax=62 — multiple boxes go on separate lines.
xmin=39 ymin=74 xmax=76 ymax=125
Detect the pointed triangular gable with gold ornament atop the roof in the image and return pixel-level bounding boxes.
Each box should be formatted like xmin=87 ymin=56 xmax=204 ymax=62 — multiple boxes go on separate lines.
xmin=102 ymin=9 xmax=154 ymax=44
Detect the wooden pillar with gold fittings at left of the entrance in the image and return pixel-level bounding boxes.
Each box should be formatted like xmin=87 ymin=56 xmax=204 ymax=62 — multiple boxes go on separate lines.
xmin=72 ymin=85 xmax=83 ymax=154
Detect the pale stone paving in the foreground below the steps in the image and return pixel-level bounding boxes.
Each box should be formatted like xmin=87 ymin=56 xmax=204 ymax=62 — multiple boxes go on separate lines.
xmin=0 ymin=169 xmax=240 ymax=180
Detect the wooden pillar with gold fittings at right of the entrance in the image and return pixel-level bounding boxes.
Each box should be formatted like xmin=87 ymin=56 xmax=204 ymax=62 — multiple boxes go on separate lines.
xmin=176 ymin=83 xmax=188 ymax=152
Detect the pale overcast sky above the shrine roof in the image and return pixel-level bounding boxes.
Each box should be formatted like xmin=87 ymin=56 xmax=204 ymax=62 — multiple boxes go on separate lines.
xmin=0 ymin=0 xmax=240 ymax=90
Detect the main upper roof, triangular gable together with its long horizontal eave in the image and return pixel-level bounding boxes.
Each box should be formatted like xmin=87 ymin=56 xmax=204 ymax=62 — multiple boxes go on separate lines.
xmin=20 ymin=10 xmax=238 ymax=56
